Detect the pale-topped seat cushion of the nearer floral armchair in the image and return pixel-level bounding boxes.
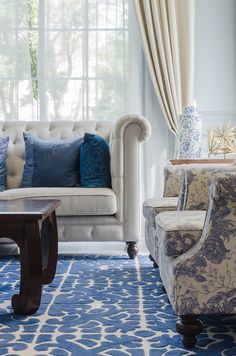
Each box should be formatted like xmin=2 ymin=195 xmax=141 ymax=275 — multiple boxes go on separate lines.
xmin=156 ymin=210 xmax=206 ymax=257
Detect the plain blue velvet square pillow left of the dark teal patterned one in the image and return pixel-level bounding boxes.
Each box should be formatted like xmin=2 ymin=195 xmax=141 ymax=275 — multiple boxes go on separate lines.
xmin=21 ymin=132 xmax=83 ymax=188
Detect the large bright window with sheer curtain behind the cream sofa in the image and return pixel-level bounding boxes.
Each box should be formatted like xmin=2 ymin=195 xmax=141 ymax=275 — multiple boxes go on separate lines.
xmin=0 ymin=0 xmax=129 ymax=120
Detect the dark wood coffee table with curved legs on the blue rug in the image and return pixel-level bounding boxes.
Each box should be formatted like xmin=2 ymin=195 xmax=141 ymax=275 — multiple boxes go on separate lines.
xmin=0 ymin=199 xmax=60 ymax=314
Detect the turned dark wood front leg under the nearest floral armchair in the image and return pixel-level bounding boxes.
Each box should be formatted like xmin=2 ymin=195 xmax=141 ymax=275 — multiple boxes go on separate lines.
xmin=176 ymin=315 xmax=202 ymax=347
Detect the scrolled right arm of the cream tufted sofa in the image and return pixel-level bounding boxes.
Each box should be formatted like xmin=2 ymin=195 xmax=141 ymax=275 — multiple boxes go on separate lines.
xmin=110 ymin=115 xmax=151 ymax=241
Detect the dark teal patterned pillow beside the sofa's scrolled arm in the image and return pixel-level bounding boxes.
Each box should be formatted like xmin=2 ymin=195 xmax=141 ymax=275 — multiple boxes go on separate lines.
xmin=80 ymin=133 xmax=111 ymax=188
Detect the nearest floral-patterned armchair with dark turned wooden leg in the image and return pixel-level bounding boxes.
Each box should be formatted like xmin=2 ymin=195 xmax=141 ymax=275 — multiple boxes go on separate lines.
xmin=156 ymin=166 xmax=236 ymax=347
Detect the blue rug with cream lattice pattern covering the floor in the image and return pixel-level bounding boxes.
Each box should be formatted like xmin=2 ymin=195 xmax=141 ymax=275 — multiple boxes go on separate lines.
xmin=0 ymin=256 xmax=236 ymax=356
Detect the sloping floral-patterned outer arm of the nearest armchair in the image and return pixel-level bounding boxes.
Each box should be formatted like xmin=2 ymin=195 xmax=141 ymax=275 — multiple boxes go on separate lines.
xmin=172 ymin=172 xmax=236 ymax=315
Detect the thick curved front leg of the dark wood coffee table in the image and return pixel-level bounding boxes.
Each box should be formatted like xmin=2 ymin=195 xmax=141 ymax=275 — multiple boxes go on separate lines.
xmin=12 ymin=221 xmax=42 ymax=314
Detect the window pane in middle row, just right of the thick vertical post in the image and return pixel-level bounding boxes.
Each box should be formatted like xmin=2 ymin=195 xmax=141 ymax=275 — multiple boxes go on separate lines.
xmin=46 ymin=31 xmax=84 ymax=77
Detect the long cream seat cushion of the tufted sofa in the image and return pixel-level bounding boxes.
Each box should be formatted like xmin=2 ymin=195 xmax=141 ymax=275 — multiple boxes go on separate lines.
xmin=0 ymin=187 xmax=117 ymax=216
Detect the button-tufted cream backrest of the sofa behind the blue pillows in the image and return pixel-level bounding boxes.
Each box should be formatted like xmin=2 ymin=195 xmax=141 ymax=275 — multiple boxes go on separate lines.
xmin=0 ymin=121 xmax=114 ymax=189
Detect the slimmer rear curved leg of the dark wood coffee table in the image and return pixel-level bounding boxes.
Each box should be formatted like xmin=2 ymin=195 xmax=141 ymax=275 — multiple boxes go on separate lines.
xmin=41 ymin=211 xmax=58 ymax=284
